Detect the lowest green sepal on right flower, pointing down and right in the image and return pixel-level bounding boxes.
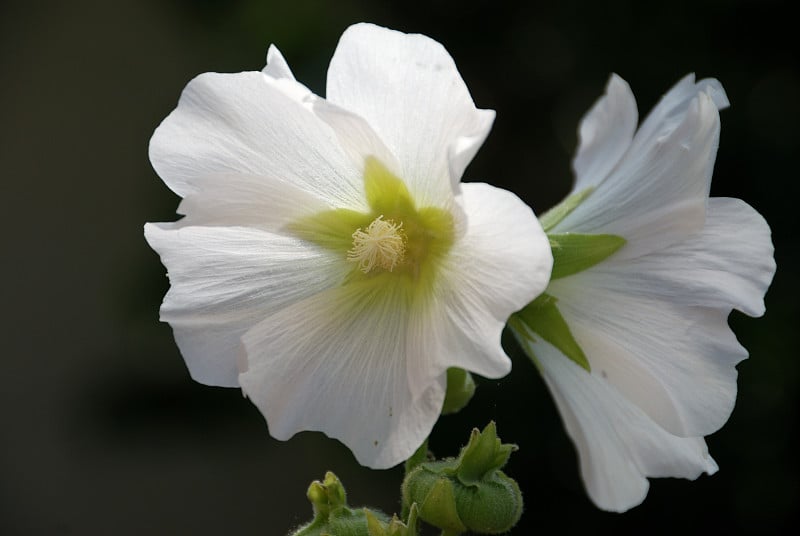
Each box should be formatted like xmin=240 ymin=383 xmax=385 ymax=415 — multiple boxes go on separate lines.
xmin=508 ymin=294 xmax=591 ymax=371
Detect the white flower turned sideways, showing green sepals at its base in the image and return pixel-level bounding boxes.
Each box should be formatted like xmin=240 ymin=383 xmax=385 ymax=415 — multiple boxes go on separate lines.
xmin=511 ymin=76 xmax=775 ymax=511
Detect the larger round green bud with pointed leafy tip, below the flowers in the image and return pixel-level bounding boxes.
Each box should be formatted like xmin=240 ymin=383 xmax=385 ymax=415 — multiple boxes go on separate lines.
xmin=403 ymin=422 xmax=522 ymax=534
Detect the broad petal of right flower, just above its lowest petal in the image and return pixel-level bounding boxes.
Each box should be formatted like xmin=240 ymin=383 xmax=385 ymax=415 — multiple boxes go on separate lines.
xmin=548 ymin=270 xmax=747 ymax=437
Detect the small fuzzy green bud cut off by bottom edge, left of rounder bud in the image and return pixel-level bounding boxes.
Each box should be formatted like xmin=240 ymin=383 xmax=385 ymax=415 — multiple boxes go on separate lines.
xmin=291 ymin=471 xmax=394 ymax=536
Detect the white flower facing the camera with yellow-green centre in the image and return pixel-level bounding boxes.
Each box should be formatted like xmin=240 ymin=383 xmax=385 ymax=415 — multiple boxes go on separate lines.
xmin=145 ymin=24 xmax=552 ymax=468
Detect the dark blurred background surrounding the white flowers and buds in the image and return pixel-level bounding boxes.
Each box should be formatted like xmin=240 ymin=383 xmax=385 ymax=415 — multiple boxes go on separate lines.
xmin=0 ymin=0 xmax=800 ymax=535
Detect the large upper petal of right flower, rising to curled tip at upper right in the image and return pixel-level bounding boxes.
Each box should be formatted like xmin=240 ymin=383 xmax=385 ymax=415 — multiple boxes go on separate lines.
xmin=553 ymin=93 xmax=719 ymax=258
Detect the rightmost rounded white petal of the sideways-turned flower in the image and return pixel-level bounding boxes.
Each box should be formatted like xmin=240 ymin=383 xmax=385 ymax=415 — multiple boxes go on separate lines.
xmin=608 ymin=197 xmax=775 ymax=316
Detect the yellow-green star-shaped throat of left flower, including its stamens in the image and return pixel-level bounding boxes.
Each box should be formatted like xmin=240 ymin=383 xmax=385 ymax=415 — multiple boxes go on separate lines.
xmin=288 ymin=157 xmax=454 ymax=294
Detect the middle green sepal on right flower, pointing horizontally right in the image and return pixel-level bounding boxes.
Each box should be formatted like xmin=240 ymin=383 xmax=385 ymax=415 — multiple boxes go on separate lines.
xmin=547 ymin=233 xmax=627 ymax=281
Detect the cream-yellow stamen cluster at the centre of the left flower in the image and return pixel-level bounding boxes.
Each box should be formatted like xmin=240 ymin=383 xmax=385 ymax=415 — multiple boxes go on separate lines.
xmin=347 ymin=215 xmax=406 ymax=274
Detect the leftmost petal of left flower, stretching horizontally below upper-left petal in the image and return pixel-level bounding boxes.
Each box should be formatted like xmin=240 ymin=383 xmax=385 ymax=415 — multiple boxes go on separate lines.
xmin=145 ymin=223 xmax=349 ymax=387
